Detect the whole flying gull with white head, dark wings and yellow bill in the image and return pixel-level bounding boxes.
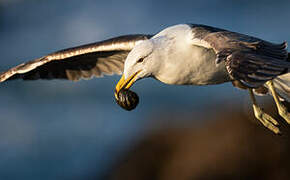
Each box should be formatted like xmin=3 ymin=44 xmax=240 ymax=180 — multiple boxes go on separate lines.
xmin=0 ymin=24 xmax=290 ymax=133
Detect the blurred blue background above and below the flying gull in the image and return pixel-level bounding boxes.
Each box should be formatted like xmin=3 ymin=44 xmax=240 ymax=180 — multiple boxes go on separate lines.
xmin=0 ymin=0 xmax=290 ymax=180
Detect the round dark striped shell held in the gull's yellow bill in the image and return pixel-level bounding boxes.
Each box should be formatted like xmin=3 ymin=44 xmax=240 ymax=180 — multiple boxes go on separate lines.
xmin=116 ymin=89 xmax=139 ymax=111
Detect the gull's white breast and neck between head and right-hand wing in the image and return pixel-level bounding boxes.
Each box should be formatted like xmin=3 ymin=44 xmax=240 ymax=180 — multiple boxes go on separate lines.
xmin=153 ymin=25 xmax=229 ymax=85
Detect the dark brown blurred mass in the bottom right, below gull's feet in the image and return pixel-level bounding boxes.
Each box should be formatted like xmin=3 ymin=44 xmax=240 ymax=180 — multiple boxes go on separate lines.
xmin=105 ymin=102 xmax=290 ymax=180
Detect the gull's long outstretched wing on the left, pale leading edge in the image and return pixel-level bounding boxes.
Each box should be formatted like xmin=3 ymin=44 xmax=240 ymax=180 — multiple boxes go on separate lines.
xmin=0 ymin=35 xmax=152 ymax=82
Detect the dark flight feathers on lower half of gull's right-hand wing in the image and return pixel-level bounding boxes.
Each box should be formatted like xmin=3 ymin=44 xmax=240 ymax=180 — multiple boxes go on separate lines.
xmin=225 ymin=47 xmax=290 ymax=88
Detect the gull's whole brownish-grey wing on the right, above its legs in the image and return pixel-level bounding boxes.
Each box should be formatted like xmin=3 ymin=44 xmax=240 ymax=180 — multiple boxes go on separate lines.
xmin=191 ymin=25 xmax=290 ymax=88
